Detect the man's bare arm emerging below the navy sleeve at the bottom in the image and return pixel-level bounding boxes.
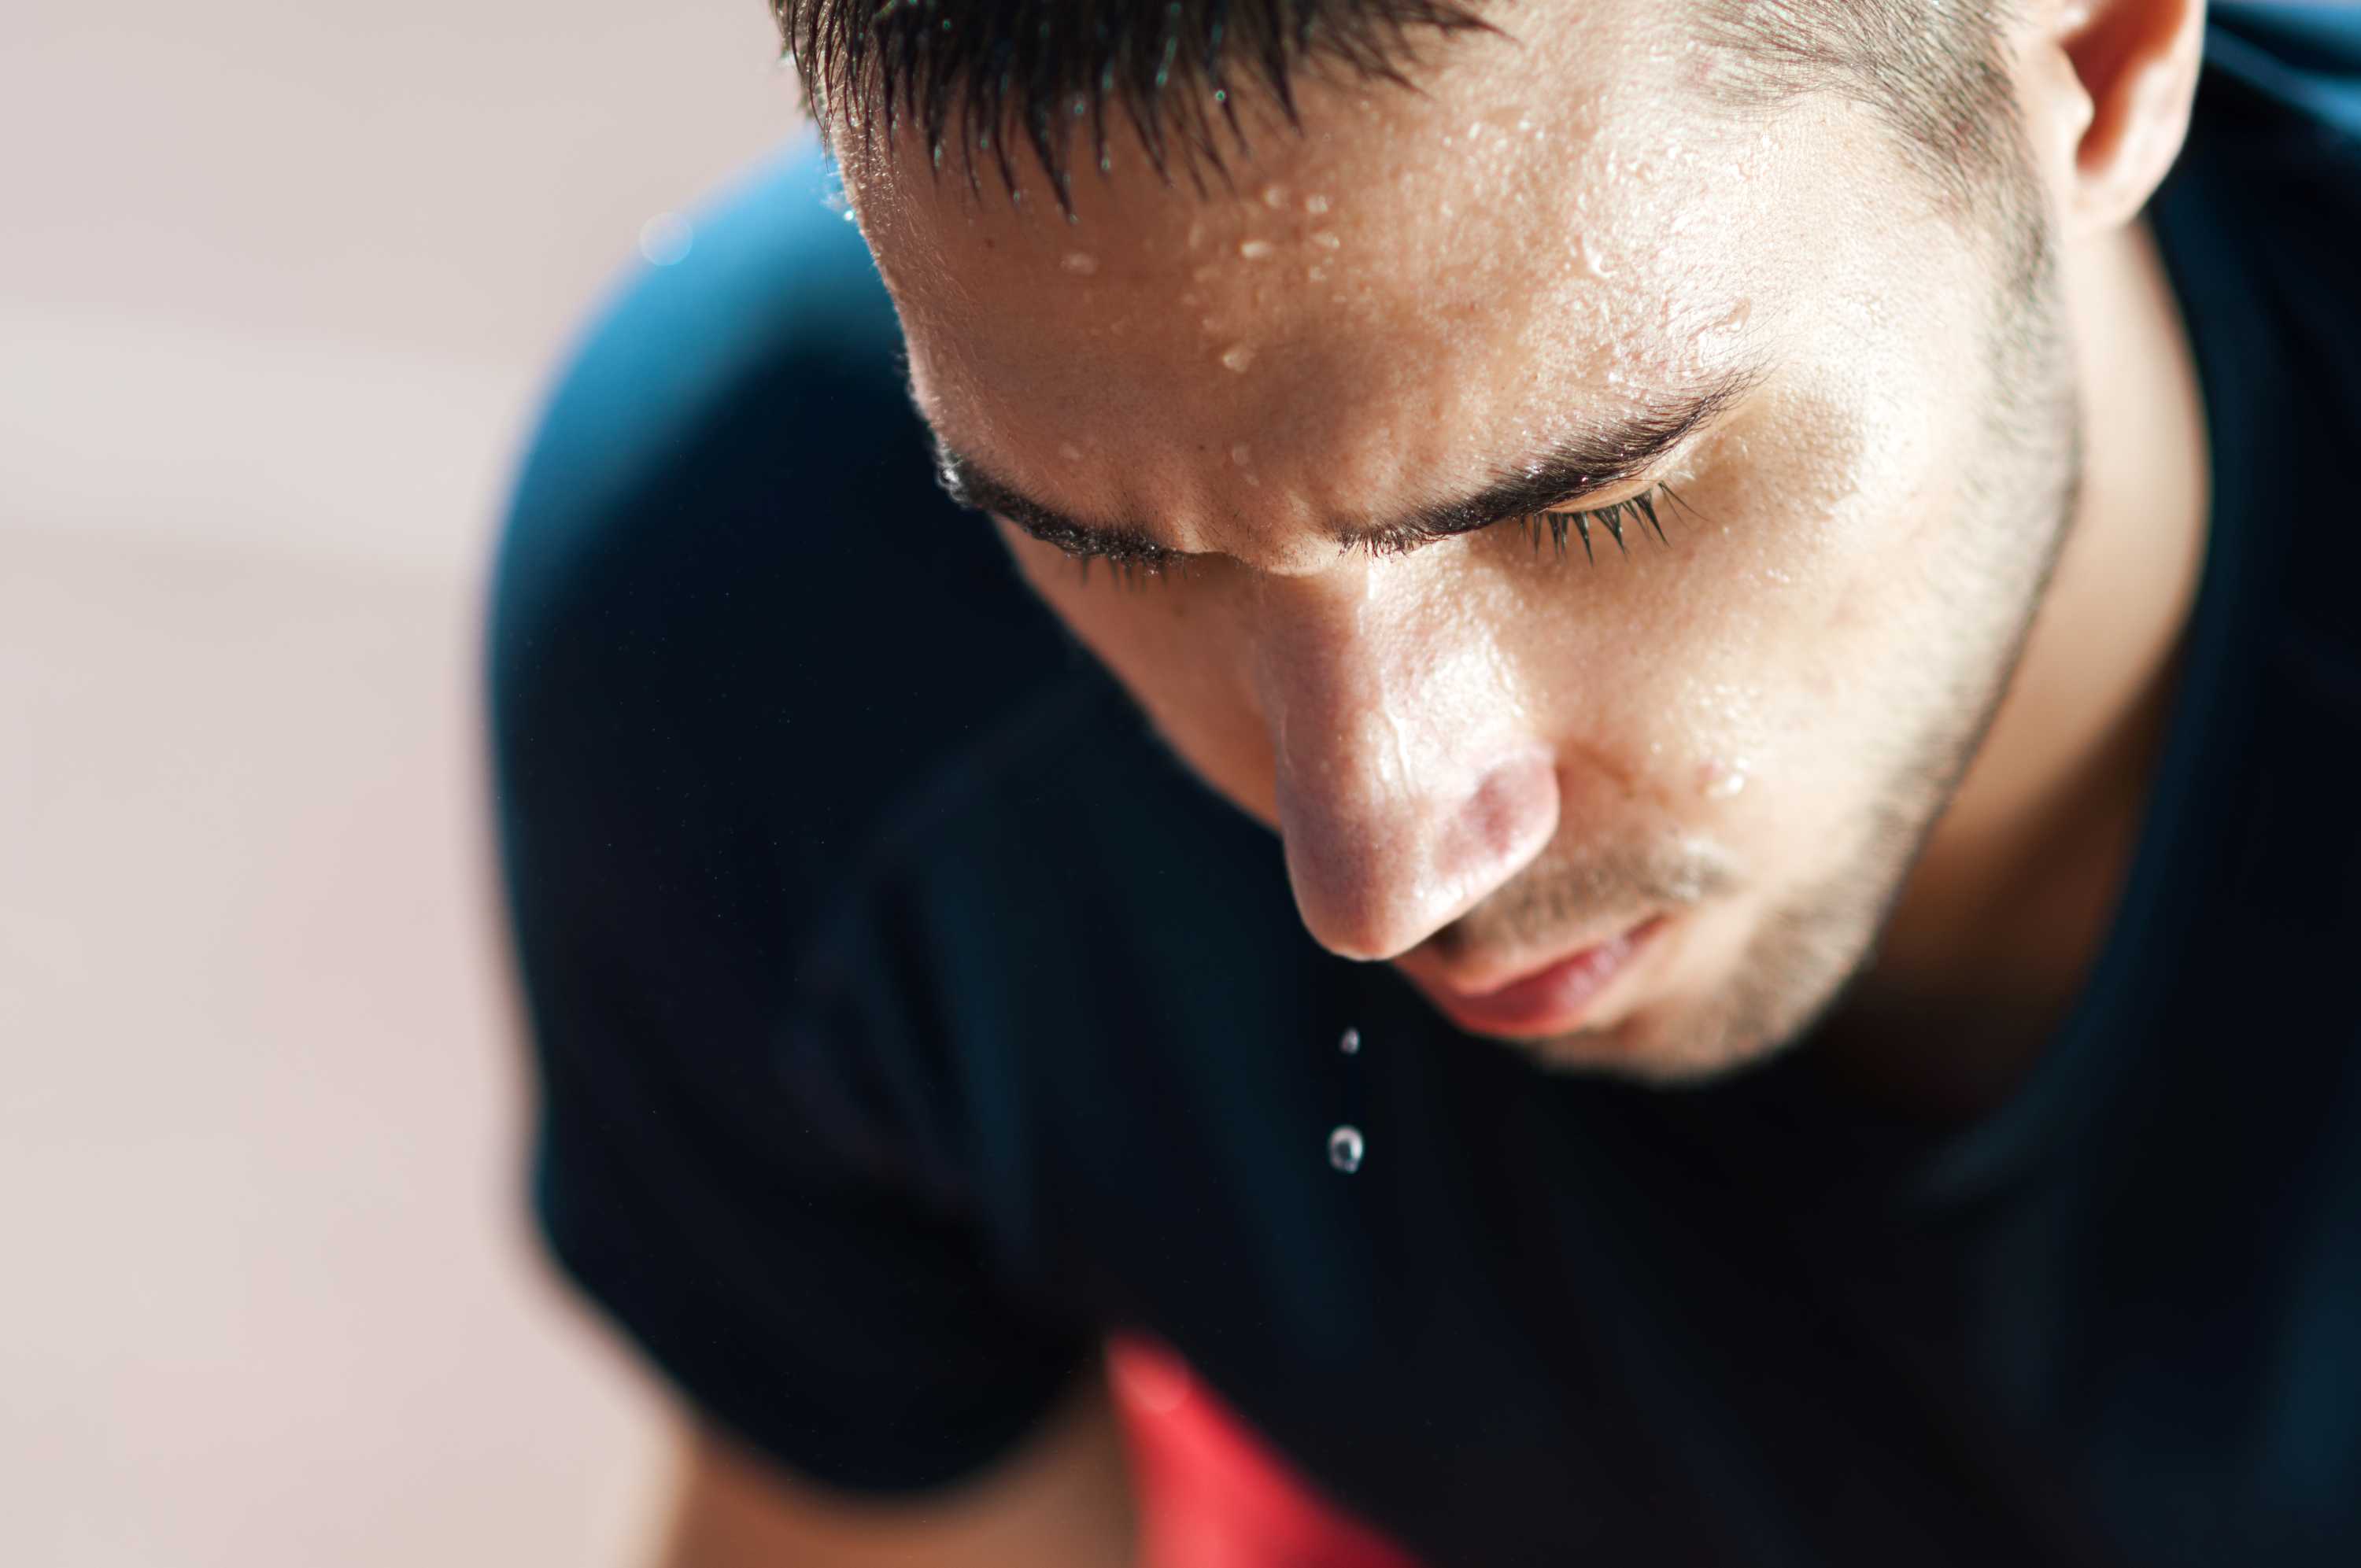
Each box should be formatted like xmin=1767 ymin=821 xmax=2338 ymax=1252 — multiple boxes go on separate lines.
xmin=656 ymin=1367 xmax=1136 ymax=1568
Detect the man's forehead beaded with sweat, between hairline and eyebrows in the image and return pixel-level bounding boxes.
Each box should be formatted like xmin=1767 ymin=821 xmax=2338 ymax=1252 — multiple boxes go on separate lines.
xmin=845 ymin=0 xmax=1768 ymax=529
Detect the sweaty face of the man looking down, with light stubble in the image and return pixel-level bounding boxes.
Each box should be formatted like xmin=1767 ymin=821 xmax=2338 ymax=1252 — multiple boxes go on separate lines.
xmin=845 ymin=0 xmax=2073 ymax=1079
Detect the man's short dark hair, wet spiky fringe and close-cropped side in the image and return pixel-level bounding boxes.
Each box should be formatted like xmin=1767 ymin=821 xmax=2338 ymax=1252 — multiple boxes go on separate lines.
xmin=770 ymin=0 xmax=2021 ymax=215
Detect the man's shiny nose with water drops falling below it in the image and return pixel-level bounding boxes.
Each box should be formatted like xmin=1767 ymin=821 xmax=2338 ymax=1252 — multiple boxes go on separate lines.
xmin=1261 ymin=581 xmax=1558 ymax=959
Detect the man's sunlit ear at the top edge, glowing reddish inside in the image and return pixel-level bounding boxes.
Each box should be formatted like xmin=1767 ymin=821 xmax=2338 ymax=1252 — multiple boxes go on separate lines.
xmin=2030 ymin=0 xmax=2205 ymax=234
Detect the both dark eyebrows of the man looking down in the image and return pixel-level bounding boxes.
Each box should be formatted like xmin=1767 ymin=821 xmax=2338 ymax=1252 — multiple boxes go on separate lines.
xmin=935 ymin=363 xmax=1766 ymax=559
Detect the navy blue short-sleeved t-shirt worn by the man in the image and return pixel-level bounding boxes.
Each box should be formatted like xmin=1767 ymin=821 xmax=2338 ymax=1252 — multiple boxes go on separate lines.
xmin=489 ymin=5 xmax=2361 ymax=1568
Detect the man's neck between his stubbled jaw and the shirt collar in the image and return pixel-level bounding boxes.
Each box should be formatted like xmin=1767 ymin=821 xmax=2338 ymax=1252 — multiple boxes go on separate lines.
xmin=1813 ymin=224 xmax=2210 ymax=1120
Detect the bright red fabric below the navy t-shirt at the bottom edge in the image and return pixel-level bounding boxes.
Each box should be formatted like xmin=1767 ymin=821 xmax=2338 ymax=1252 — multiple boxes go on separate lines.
xmin=1107 ymin=1334 xmax=1419 ymax=1568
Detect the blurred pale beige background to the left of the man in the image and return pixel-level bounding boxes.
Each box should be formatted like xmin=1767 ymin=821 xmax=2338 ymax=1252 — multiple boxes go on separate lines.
xmin=0 ymin=0 xmax=796 ymax=1568
